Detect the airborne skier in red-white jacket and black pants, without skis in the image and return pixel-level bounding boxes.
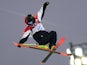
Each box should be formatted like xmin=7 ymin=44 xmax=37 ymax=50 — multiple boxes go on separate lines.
xmin=18 ymin=2 xmax=57 ymax=49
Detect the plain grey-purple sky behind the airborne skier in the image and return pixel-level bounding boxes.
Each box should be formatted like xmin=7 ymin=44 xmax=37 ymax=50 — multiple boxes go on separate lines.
xmin=0 ymin=0 xmax=87 ymax=65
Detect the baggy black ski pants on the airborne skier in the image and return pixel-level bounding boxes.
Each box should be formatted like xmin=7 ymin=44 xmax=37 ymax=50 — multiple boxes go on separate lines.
xmin=33 ymin=31 xmax=57 ymax=48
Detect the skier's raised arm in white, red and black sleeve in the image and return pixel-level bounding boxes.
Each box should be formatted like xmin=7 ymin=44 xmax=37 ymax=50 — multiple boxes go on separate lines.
xmin=35 ymin=2 xmax=49 ymax=21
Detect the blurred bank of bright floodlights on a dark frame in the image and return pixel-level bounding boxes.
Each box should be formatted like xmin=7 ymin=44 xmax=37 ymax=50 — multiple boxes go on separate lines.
xmin=67 ymin=43 xmax=87 ymax=65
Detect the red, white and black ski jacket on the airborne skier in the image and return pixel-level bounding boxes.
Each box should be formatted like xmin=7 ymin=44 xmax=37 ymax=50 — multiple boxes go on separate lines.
xmin=22 ymin=3 xmax=47 ymax=38
